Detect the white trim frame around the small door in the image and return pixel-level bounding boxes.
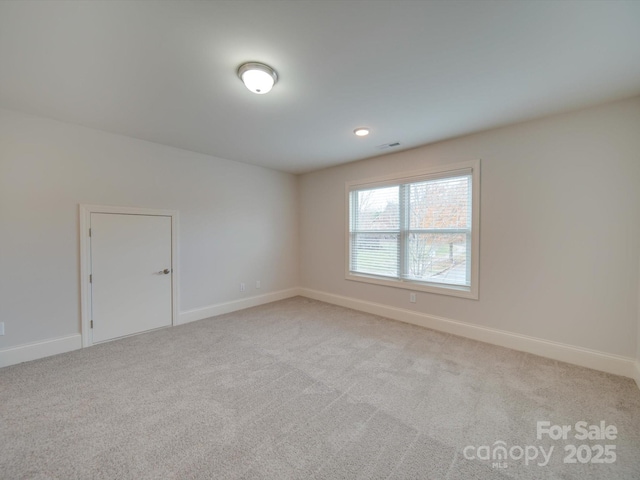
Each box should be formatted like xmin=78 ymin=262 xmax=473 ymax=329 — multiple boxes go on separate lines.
xmin=79 ymin=204 xmax=180 ymax=348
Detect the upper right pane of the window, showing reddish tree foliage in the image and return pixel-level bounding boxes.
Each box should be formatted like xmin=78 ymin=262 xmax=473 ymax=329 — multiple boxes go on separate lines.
xmin=409 ymin=175 xmax=471 ymax=230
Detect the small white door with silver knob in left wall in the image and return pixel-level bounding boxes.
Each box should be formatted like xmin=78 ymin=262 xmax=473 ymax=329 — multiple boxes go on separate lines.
xmin=90 ymin=212 xmax=173 ymax=343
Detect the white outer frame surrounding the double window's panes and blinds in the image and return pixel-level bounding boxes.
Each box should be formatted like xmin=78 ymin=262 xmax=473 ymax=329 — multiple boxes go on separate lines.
xmin=345 ymin=159 xmax=480 ymax=300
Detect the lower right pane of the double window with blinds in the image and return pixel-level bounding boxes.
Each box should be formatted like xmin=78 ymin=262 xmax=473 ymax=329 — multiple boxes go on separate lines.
xmin=407 ymin=233 xmax=469 ymax=285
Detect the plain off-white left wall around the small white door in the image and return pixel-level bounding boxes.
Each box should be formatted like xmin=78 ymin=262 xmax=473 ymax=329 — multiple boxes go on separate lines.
xmin=0 ymin=110 xmax=298 ymax=349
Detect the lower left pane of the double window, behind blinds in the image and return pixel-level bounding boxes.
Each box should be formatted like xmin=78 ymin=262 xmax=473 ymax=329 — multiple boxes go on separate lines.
xmin=351 ymin=233 xmax=400 ymax=278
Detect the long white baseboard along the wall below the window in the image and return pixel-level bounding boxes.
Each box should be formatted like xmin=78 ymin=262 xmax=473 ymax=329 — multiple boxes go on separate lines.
xmin=299 ymin=288 xmax=640 ymax=380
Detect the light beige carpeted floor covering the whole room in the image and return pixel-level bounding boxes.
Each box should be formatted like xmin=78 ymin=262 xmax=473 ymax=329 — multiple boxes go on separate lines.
xmin=0 ymin=297 xmax=640 ymax=480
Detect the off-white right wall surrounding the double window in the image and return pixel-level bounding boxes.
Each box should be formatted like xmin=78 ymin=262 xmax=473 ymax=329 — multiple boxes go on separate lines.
xmin=300 ymin=98 xmax=640 ymax=358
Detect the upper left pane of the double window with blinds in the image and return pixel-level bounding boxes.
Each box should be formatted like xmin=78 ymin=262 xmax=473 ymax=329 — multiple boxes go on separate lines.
xmin=352 ymin=186 xmax=400 ymax=231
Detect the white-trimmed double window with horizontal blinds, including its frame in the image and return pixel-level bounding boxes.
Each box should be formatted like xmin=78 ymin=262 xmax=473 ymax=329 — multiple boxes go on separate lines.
xmin=346 ymin=160 xmax=480 ymax=299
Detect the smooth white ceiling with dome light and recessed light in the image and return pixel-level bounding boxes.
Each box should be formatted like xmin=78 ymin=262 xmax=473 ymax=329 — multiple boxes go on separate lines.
xmin=0 ymin=0 xmax=640 ymax=173
